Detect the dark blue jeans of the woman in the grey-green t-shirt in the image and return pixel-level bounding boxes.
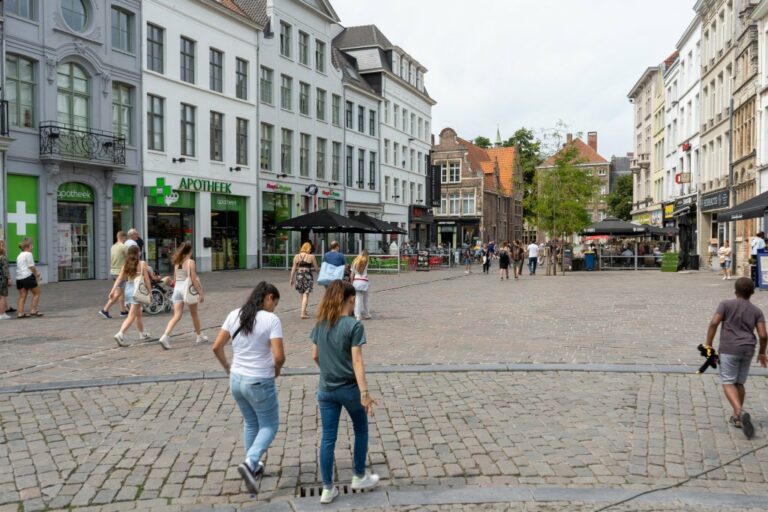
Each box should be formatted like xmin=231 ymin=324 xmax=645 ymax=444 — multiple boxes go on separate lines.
xmin=317 ymin=384 xmax=368 ymax=488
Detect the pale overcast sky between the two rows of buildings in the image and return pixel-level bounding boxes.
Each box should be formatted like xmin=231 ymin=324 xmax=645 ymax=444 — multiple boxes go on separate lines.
xmin=331 ymin=0 xmax=695 ymax=158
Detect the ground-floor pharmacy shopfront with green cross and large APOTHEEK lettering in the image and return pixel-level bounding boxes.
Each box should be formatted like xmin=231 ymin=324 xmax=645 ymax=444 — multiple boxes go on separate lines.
xmin=144 ymin=176 xmax=257 ymax=275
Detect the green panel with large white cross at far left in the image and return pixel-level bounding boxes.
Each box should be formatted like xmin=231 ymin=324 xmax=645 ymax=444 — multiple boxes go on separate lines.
xmin=5 ymin=174 xmax=40 ymax=261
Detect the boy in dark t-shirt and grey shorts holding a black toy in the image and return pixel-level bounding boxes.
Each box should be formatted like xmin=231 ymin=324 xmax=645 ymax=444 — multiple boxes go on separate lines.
xmin=706 ymin=277 xmax=768 ymax=439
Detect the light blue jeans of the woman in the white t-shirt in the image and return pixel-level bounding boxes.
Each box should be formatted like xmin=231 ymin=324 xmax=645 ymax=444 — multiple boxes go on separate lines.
xmin=229 ymin=373 xmax=280 ymax=468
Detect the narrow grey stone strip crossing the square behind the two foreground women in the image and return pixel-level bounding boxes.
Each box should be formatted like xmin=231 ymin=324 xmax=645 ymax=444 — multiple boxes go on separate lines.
xmin=0 ymin=363 xmax=768 ymax=394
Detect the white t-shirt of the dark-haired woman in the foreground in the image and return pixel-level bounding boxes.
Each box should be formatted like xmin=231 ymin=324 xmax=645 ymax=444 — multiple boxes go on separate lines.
xmin=221 ymin=308 xmax=283 ymax=379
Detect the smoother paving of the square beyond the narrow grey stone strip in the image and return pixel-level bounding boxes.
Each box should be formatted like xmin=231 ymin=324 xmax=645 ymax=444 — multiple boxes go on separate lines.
xmin=0 ymin=270 xmax=768 ymax=386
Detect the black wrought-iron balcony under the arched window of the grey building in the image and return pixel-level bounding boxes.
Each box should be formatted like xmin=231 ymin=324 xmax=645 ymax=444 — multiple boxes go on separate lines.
xmin=40 ymin=121 xmax=125 ymax=167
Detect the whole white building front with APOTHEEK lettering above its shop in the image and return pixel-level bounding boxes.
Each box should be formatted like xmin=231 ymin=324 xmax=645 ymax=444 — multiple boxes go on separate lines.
xmin=141 ymin=0 xmax=262 ymax=273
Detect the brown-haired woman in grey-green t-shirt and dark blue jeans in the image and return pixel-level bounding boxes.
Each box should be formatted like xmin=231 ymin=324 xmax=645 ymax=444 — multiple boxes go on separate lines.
xmin=310 ymin=281 xmax=379 ymax=504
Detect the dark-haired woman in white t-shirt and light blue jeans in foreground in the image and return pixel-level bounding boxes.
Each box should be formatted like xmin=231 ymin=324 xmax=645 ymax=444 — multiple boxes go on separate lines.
xmin=213 ymin=281 xmax=285 ymax=494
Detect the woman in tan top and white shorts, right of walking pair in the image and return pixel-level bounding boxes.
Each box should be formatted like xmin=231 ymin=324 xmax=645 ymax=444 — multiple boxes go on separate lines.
xmin=158 ymin=242 xmax=208 ymax=350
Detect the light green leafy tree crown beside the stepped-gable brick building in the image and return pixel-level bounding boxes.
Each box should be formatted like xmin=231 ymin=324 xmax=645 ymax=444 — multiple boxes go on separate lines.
xmin=532 ymin=146 xmax=600 ymax=238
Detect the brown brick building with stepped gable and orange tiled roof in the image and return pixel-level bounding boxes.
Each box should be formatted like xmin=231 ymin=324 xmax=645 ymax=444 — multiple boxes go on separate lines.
xmin=432 ymin=128 xmax=523 ymax=247
